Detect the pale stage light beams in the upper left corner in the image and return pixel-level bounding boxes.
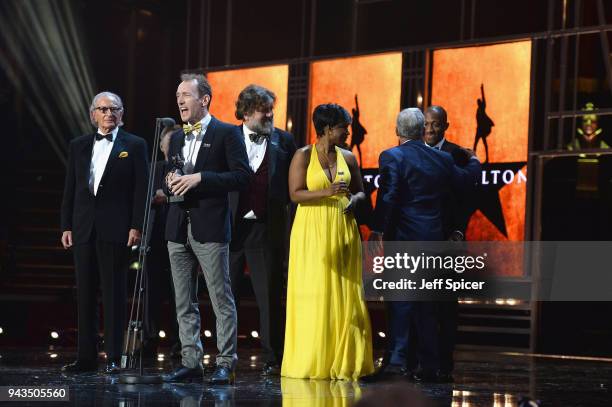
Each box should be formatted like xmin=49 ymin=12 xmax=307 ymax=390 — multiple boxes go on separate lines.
xmin=0 ymin=1 xmax=94 ymax=164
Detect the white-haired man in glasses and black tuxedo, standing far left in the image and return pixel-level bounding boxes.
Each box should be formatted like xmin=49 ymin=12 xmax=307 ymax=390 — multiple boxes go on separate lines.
xmin=61 ymin=92 xmax=147 ymax=373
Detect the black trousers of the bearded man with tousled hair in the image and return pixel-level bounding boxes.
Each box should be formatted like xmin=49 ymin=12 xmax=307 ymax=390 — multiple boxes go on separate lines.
xmin=230 ymin=219 xmax=285 ymax=364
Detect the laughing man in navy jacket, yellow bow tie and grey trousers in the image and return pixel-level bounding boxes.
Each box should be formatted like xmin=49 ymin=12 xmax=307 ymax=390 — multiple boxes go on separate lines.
xmin=164 ymin=74 xmax=252 ymax=384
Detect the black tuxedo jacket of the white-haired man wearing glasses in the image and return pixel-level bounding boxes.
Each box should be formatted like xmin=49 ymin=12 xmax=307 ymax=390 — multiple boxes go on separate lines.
xmin=61 ymin=128 xmax=148 ymax=245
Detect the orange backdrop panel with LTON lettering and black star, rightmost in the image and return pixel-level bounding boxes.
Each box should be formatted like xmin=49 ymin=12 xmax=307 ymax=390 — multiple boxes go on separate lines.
xmin=431 ymin=41 xmax=531 ymax=275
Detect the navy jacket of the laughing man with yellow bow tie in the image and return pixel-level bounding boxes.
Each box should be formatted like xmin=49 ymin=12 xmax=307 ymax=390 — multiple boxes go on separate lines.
xmin=164 ymin=117 xmax=253 ymax=243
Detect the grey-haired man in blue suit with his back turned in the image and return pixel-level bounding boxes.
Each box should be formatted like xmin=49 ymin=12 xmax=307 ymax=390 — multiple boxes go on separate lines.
xmin=371 ymin=108 xmax=480 ymax=380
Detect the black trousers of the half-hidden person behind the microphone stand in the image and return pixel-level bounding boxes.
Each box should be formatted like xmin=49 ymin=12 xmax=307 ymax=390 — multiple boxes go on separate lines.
xmin=143 ymin=241 xmax=178 ymax=350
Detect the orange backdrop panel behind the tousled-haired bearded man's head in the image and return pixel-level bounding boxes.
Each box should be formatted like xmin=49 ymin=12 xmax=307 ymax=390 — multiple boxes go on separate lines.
xmin=207 ymin=65 xmax=289 ymax=129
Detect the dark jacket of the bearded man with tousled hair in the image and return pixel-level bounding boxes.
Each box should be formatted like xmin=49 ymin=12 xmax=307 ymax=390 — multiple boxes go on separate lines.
xmin=230 ymin=125 xmax=296 ymax=247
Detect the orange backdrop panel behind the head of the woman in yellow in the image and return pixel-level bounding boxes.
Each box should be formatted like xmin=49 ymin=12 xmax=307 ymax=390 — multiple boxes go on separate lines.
xmin=308 ymin=53 xmax=402 ymax=168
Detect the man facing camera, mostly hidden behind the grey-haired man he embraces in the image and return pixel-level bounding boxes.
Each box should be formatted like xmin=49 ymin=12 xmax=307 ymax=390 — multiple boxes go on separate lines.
xmin=423 ymin=105 xmax=473 ymax=381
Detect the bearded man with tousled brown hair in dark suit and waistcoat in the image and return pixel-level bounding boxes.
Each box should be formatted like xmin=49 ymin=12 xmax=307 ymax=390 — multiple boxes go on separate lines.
xmin=230 ymin=85 xmax=296 ymax=375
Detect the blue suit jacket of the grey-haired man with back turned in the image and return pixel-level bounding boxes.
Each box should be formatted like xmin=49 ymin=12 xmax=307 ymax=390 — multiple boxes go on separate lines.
xmin=373 ymin=140 xmax=480 ymax=241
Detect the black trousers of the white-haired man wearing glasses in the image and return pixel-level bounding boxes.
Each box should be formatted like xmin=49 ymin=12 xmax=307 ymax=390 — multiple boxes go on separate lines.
xmin=72 ymin=241 xmax=128 ymax=361
